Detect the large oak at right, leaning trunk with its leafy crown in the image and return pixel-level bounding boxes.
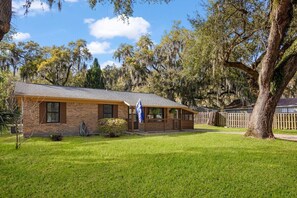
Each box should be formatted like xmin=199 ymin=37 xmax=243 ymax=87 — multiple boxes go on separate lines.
xmin=192 ymin=0 xmax=297 ymax=138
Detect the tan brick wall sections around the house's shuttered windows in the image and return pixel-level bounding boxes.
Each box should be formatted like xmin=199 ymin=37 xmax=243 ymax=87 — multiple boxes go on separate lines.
xmin=23 ymin=99 xmax=128 ymax=136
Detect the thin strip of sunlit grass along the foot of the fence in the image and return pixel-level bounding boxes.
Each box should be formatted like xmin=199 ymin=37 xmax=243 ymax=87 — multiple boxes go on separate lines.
xmin=195 ymin=124 xmax=297 ymax=135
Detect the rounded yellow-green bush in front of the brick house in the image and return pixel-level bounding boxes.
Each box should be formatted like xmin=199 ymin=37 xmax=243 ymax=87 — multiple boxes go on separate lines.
xmin=98 ymin=118 xmax=128 ymax=137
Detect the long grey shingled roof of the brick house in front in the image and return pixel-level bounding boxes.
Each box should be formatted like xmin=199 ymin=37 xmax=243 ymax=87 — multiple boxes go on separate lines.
xmin=15 ymin=82 xmax=193 ymax=111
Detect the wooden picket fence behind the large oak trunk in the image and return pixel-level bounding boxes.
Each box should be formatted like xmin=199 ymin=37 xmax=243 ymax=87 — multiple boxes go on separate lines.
xmin=194 ymin=112 xmax=297 ymax=130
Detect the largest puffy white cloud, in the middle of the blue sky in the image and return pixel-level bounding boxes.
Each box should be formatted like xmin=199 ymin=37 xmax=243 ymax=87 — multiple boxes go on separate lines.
xmin=89 ymin=16 xmax=150 ymax=40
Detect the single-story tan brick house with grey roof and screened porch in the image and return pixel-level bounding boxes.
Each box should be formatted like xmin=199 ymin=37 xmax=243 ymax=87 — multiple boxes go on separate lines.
xmin=15 ymin=82 xmax=195 ymax=136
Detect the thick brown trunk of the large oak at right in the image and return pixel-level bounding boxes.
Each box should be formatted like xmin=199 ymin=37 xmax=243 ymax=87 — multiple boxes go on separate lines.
xmin=245 ymin=0 xmax=297 ymax=138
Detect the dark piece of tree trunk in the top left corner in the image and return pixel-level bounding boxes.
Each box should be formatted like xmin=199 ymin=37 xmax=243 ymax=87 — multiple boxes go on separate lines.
xmin=0 ymin=0 xmax=12 ymax=41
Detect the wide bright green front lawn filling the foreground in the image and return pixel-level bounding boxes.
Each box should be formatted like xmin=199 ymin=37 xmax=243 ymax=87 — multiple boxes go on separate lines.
xmin=0 ymin=133 xmax=297 ymax=197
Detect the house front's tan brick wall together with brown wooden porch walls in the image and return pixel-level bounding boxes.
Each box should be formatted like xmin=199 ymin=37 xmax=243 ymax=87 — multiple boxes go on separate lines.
xmin=20 ymin=99 xmax=194 ymax=136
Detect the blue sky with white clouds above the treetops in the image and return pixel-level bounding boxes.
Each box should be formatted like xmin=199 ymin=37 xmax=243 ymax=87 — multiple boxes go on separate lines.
xmin=12 ymin=0 xmax=205 ymax=67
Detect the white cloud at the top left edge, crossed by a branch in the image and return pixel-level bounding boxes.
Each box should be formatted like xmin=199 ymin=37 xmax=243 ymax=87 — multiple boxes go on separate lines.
xmin=12 ymin=0 xmax=50 ymax=15
